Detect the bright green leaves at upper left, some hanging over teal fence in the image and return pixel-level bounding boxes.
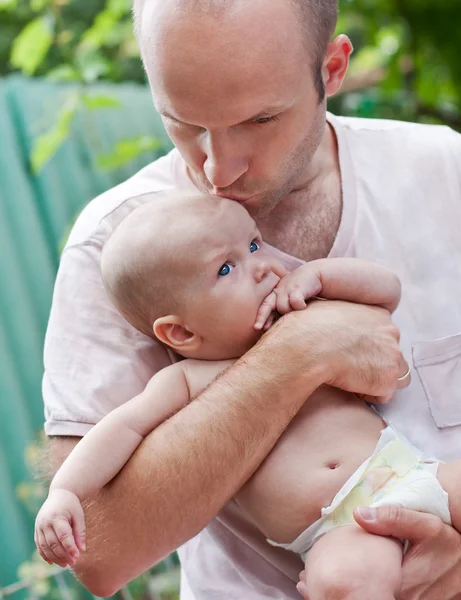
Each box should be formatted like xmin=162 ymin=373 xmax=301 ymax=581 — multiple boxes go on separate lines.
xmin=0 ymin=0 xmax=155 ymax=172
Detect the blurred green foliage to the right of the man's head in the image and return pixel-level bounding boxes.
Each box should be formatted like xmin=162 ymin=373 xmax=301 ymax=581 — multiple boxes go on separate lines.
xmin=333 ymin=0 xmax=461 ymax=130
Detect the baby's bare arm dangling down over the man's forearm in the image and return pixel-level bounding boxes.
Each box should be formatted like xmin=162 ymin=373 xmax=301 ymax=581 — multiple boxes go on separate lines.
xmin=35 ymin=360 xmax=232 ymax=566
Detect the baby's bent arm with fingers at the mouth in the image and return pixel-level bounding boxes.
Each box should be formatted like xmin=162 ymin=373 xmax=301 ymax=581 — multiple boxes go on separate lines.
xmin=255 ymin=258 xmax=401 ymax=329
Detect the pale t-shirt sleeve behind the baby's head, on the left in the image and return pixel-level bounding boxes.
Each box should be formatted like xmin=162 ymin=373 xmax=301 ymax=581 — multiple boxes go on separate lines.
xmin=43 ymin=242 xmax=171 ymax=436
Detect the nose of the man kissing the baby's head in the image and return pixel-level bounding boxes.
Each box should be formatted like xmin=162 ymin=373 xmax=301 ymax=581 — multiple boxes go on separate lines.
xmin=203 ymin=132 xmax=248 ymax=189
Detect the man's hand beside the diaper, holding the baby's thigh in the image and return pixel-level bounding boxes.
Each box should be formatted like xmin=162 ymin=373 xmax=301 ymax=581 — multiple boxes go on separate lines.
xmin=354 ymin=506 xmax=461 ymax=600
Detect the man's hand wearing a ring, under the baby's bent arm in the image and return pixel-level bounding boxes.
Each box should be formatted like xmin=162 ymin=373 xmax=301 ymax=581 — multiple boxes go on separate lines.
xmin=262 ymin=300 xmax=410 ymax=402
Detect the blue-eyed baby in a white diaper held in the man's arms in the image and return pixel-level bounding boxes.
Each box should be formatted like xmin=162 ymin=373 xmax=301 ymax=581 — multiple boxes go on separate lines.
xmin=35 ymin=193 xmax=461 ymax=600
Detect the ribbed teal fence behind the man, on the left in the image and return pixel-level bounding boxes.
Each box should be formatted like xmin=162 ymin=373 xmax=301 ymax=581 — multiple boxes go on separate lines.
xmin=0 ymin=76 xmax=171 ymax=587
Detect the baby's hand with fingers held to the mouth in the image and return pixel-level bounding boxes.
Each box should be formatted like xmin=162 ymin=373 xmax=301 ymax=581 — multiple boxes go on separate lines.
xmin=254 ymin=265 xmax=322 ymax=331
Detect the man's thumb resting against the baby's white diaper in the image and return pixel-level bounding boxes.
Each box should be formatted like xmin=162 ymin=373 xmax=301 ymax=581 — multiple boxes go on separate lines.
xmin=354 ymin=506 xmax=443 ymax=545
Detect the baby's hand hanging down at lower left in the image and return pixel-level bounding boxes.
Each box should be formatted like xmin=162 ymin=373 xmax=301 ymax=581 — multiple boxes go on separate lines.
xmin=34 ymin=489 xmax=86 ymax=567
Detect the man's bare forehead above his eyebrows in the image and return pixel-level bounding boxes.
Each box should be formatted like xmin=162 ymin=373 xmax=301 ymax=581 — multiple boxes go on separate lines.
xmin=142 ymin=0 xmax=306 ymax=126
